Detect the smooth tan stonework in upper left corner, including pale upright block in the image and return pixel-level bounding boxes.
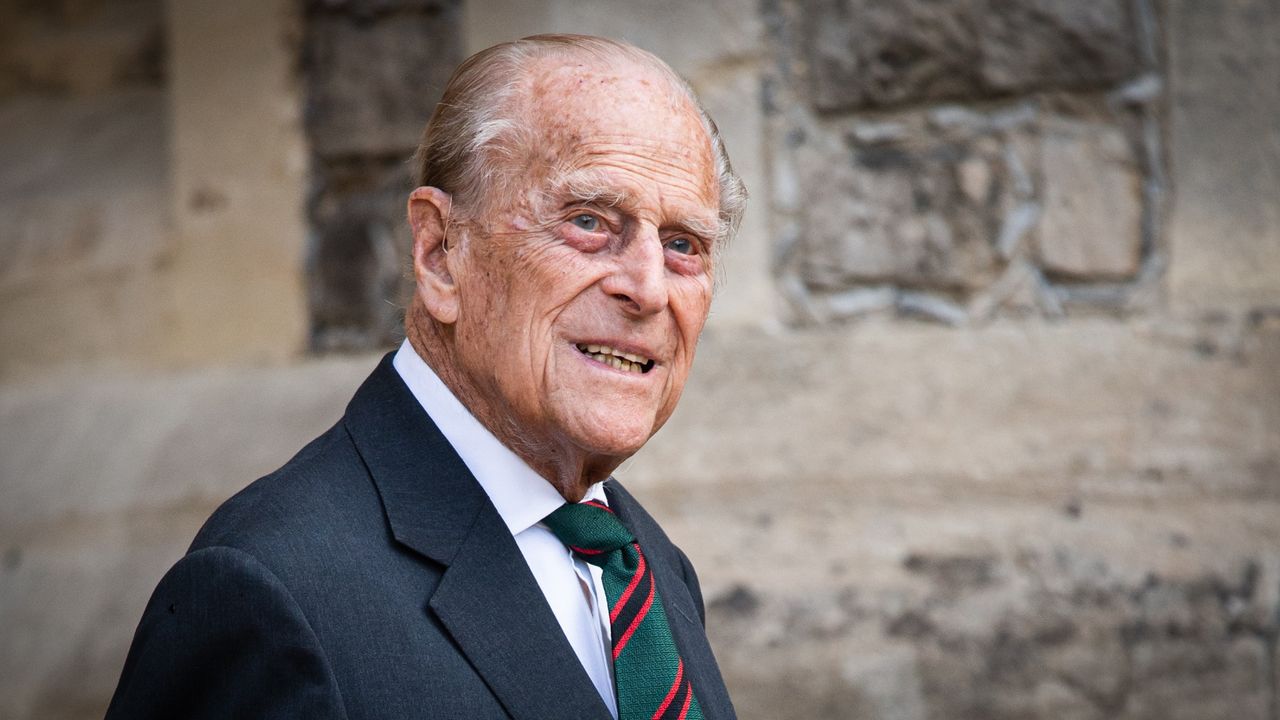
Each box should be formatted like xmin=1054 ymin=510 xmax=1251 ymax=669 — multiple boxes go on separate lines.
xmin=0 ymin=0 xmax=307 ymax=378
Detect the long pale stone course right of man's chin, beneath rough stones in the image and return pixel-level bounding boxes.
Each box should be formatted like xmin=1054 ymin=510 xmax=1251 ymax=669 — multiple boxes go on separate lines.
xmin=626 ymin=319 xmax=1280 ymax=497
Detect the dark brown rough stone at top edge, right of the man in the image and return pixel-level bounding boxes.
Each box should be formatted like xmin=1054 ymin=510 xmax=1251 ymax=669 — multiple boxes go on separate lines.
xmin=803 ymin=0 xmax=1140 ymax=111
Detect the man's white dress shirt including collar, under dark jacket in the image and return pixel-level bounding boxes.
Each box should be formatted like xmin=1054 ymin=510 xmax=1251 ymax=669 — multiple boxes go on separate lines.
xmin=392 ymin=340 xmax=618 ymax=717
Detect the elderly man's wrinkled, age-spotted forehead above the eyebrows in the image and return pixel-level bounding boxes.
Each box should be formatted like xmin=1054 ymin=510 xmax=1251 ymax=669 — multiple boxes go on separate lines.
xmin=526 ymin=58 xmax=718 ymax=201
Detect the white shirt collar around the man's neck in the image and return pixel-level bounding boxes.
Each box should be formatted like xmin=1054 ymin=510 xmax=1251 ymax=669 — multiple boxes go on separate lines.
xmin=392 ymin=340 xmax=605 ymax=536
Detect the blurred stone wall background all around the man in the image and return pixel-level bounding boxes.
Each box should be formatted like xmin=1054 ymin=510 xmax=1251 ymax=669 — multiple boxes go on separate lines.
xmin=0 ymin=0 xmax=1280 ymax=720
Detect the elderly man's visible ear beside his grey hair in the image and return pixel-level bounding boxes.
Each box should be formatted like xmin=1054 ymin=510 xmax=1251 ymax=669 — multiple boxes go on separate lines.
xmin=408 ymin=187 xmax=458 ymax=324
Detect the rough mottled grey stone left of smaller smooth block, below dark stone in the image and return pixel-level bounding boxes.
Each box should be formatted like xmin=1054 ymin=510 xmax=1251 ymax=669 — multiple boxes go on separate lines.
xmin=792 ymin=117 xmax=1016 ymax=291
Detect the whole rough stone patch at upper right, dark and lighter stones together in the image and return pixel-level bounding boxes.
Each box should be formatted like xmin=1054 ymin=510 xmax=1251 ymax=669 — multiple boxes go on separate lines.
xmin=767 ymin=0 xmax=1167 ymax=324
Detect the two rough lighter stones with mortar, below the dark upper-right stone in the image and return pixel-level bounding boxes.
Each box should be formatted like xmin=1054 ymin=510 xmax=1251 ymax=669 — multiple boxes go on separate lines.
xmin=772 ymin=78 xmax=1164 ymax=316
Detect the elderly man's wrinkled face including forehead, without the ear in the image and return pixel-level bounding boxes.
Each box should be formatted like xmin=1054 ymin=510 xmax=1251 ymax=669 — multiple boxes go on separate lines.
xmin=451 ymin=63 xmax=718 ymax=457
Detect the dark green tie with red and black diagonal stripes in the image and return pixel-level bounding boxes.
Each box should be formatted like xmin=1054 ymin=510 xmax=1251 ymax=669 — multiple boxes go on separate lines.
xmin=543 ymin=500 xmax=703 ymax=720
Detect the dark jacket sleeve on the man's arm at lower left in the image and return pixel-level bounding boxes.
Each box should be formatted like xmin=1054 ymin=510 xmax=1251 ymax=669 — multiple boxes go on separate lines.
xmin=106 ymin=547 xmax=347 ymax=720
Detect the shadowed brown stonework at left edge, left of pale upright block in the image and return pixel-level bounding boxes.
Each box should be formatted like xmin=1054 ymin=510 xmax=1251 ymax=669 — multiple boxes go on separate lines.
xmin=0 ymin=1 xmax=169 ymax=377
